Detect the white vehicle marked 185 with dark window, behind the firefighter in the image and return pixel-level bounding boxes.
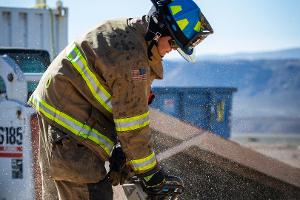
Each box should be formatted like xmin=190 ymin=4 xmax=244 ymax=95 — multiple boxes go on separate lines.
xmin=0 ymin=49 xmax=50 ymax=200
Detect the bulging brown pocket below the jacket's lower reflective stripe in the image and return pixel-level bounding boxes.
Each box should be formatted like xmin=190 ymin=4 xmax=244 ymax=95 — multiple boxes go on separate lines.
xmin=49 ymin=127 xmax=106 ymax=184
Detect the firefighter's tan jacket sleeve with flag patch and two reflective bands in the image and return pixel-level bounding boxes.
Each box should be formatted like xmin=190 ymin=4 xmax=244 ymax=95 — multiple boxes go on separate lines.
xmin=112 ymin=67 xmax=159 ymax=175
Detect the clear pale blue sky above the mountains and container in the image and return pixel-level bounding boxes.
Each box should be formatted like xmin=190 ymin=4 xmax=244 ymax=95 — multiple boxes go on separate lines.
xmin=0 ymin=0 xmax=300 ymax=57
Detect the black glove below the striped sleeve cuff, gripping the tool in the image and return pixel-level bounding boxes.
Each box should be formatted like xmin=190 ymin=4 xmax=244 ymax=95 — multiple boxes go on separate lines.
xmin=142 ymin=170 xmax=184 ymax=197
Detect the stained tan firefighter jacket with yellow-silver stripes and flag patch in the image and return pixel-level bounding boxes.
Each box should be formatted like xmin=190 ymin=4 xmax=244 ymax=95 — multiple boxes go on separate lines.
xmin=29 ymin=17 xmax=163 ymax=173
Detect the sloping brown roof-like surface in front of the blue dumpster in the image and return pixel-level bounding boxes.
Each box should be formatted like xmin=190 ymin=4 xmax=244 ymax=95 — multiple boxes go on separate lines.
xmin=150 ymin=110 xmax=300 ymax=199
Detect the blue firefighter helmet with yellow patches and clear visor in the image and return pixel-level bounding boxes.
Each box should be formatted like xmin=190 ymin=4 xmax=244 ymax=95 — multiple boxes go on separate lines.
xmin=151 ymin=0 xmax=213 ymax=59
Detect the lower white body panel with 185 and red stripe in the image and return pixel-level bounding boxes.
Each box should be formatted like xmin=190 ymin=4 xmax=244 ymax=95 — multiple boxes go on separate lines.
xmin=0 ymin=99 xmax=35 ymax=200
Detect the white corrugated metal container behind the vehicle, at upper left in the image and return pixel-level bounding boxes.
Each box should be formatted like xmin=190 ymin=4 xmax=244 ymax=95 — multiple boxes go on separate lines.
xmin=0 ymin=7 xmax=68 ymax=59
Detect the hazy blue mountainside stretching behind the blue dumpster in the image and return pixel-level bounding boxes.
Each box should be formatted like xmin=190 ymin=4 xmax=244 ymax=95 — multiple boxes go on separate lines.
xmin=154 ymin=55 xmax=300 ymax=133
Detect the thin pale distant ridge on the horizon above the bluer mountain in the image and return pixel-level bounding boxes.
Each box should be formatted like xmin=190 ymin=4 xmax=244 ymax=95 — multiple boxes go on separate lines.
xmin=199 ymin=47 xmax=300 ymax=60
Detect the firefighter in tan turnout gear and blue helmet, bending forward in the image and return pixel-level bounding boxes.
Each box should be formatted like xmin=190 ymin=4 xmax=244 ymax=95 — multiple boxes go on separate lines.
xmin=29 ymin=0 xmax=213 ymax=200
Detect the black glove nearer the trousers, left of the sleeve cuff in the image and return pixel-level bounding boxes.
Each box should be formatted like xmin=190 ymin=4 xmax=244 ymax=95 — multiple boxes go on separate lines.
xmin=108 ymin=145 xmax=131 ymax=186
